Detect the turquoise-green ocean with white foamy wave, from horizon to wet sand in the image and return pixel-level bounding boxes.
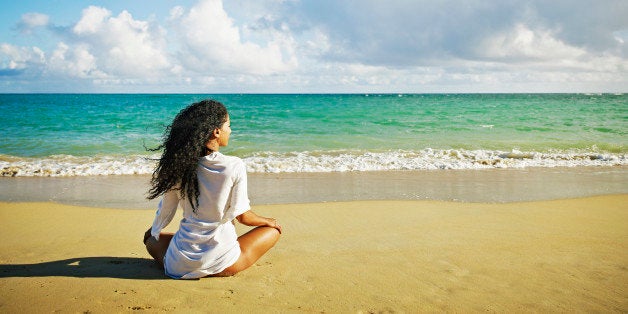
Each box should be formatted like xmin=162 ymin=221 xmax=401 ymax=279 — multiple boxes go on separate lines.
xmin=0 ymin=94 xmax=628 ymax=176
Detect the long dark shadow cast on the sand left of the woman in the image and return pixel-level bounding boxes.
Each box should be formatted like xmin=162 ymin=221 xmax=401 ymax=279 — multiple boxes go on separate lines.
xmin=0 ymin=256 xmax=168 ymax=279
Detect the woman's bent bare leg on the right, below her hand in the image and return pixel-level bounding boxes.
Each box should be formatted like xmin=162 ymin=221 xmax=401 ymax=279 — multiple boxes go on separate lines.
xmin=213 ymin=227 xmax=280 ymax=277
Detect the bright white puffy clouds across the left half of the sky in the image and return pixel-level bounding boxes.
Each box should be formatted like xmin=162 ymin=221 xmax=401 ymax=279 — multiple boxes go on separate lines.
xmin=1 ymin=0 xmax=298 ymax=84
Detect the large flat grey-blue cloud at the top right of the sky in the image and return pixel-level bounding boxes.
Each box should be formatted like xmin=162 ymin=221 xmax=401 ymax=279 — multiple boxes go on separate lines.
xmin=288 ymin=0 xmax=628 ymax=67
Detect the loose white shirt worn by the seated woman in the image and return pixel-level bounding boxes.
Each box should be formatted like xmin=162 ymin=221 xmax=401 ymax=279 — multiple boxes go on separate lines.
xmin=151 ymin=152 xmax=251 ymax=279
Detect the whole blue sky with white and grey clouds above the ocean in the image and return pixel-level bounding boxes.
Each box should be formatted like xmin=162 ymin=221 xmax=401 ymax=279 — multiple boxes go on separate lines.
xmin=0 ymin=0 xmax=628 ymax=93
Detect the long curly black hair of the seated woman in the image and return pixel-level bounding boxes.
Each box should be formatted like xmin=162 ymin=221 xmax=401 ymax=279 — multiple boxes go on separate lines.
xmin=147 ymin=100 xmax=228 ymax=211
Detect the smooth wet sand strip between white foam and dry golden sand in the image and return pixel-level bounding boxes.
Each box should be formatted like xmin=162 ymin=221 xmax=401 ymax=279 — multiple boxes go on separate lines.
xmin=0 ymin=166 xmax=628 ymax=209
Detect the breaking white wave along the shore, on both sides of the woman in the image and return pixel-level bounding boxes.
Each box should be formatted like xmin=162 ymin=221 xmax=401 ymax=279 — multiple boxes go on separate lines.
xmin=0 ymin=149 xmax=628 ymax=177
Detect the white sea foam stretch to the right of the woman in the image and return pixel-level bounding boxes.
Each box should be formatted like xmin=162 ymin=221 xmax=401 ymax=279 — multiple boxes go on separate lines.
xmin=245 ymin=149 xmax=627 ymax=173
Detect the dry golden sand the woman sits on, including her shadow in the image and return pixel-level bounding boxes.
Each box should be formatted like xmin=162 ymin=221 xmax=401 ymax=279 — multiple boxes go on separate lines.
xmin=0 ymin=194 xmax=628 ymax=313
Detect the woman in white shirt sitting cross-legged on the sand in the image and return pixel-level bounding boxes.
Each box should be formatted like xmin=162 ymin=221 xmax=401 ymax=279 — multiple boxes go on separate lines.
xmin=144 ymin=100 xmax=281 ymax=279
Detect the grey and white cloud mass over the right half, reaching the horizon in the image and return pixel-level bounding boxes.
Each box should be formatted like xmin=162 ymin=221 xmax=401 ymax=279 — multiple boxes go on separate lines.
xmin=276 ymin=0 xmax=628 ymax=91
